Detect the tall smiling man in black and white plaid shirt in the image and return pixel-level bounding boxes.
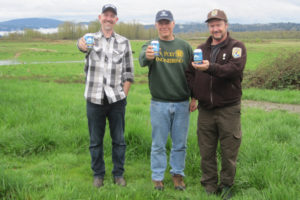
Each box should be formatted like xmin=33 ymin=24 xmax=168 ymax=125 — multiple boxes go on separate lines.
xmin=77 ymin=4 xmax=133 ymax=187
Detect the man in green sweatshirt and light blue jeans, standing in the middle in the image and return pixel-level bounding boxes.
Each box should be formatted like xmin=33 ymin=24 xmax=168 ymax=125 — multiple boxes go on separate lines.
xmin=139 ymin=10 xmax=196 ymax=190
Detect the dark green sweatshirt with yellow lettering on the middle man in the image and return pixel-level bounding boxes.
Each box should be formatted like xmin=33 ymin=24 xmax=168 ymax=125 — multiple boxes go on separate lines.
xmin=139 ymin=38 xmax=193 ymax=102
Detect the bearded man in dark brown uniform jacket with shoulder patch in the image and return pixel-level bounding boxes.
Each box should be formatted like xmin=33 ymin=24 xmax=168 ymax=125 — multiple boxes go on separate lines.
xmin=186 ymin=9 xmax=246 ymax=199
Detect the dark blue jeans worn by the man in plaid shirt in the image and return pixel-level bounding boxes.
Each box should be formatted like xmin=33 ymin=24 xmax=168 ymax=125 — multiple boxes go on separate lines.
xmin=86 ymin=99 xmax=126 ymax=178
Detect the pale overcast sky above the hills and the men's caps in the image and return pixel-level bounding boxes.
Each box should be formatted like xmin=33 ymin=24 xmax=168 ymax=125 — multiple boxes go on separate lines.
xmin=0 ymin=0 xmax=300 ymax=24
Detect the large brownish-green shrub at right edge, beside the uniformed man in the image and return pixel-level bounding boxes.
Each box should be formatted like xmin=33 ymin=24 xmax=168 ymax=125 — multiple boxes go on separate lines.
xmin=243 ymin=52 xmax=300 ymax=90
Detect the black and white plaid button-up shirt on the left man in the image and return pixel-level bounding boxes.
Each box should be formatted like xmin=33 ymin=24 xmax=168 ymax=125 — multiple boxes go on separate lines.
xmin=84 ymin=32 xmax=134 ymax=104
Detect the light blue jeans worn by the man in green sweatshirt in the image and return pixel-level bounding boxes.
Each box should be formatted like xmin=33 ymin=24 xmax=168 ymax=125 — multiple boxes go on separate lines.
xmin=150 ymin=100 xmax=190 ymax=181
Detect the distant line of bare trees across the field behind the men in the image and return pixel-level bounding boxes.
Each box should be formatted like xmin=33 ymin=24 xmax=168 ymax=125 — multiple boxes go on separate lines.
xmin=2 ymin=20 xmax=300 ymax=41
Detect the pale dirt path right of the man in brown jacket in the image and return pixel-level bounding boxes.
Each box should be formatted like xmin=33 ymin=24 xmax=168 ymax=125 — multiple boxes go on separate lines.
xmin=242 ymin=100 xmax=300 ymax=115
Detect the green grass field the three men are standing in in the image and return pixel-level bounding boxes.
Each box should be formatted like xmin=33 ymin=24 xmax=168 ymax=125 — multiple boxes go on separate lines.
xmin=0 ymin=41 xmax=300 ymax=200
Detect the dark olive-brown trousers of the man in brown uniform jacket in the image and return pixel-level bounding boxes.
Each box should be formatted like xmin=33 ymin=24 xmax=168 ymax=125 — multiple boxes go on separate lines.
xmin=197 ymin=104 xmax=242 ymax=192
